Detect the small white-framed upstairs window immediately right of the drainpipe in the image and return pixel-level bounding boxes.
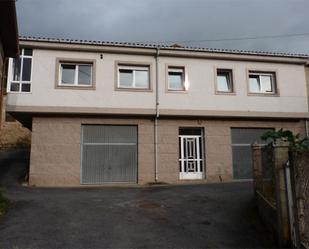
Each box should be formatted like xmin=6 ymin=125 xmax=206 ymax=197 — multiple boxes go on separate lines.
xmin=167 ymin=67 xmax=186 ymax=91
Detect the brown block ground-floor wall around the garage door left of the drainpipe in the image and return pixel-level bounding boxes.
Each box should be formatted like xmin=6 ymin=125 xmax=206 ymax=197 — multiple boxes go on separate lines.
xmin=29 ymin=118 xmax=154 ymax=186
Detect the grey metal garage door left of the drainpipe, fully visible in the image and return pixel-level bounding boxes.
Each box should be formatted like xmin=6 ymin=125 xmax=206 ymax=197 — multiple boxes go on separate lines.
xmin=81 ymin=125 xmax=137 ymax=184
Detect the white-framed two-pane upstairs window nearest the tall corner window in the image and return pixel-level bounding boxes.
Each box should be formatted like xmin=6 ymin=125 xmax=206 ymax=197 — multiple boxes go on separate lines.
xmin=58 ymin=62 xmax=93 ymax=87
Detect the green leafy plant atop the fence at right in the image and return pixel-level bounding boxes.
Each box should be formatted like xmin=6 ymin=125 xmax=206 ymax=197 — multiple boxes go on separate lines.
xmin=261 ymin=129 xmax=309 ymax=151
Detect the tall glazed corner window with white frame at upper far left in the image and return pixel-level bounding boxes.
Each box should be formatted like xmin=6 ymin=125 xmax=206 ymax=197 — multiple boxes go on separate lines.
xmin=7 ymin=48 xmax=33 ymax=93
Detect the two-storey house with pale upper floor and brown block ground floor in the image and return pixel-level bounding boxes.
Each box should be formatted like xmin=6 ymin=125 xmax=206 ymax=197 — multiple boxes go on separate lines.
xmin=7 ymin=37 xmax=309 ymax=186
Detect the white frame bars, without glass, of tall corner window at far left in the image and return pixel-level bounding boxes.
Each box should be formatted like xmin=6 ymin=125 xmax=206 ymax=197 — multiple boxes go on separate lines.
xmin=6 ymin=48 xmax=33 ymax=93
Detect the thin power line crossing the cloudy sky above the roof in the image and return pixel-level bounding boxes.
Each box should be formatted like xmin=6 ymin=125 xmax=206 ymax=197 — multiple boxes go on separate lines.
xmin=143 ymin=33 xmax=309 ymax=43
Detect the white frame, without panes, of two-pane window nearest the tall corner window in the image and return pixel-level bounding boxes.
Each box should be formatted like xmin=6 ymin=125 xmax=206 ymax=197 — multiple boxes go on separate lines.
xmin=58 ymin=61 xmax=93 ymax=88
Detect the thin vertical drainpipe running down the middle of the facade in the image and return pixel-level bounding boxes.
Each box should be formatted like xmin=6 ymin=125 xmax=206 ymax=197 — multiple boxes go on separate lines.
xmin=154 ymin=47 xmax=160 ymax=182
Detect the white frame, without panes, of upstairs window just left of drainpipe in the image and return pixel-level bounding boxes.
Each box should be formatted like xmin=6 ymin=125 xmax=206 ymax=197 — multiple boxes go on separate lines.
xmin=117 ymin=65 xmax=150 ymax=90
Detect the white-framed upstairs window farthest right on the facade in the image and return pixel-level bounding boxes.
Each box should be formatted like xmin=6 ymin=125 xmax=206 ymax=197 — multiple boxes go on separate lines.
xmin=249 ymin=71 xmax=277 ymax=94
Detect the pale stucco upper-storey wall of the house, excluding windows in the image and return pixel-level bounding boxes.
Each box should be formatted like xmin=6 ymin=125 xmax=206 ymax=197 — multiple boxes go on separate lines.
xmin=7 ymin=43 xmax=308 ymax=117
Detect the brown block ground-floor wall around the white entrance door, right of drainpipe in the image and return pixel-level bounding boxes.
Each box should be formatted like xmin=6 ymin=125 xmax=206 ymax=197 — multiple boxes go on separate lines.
xmin=158 ymin=119 xmax=305 ymax=183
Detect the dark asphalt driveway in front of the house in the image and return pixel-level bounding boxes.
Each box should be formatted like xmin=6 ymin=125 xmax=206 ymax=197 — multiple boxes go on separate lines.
xmin=0 ymin=151 xmax=274 ymax=249
